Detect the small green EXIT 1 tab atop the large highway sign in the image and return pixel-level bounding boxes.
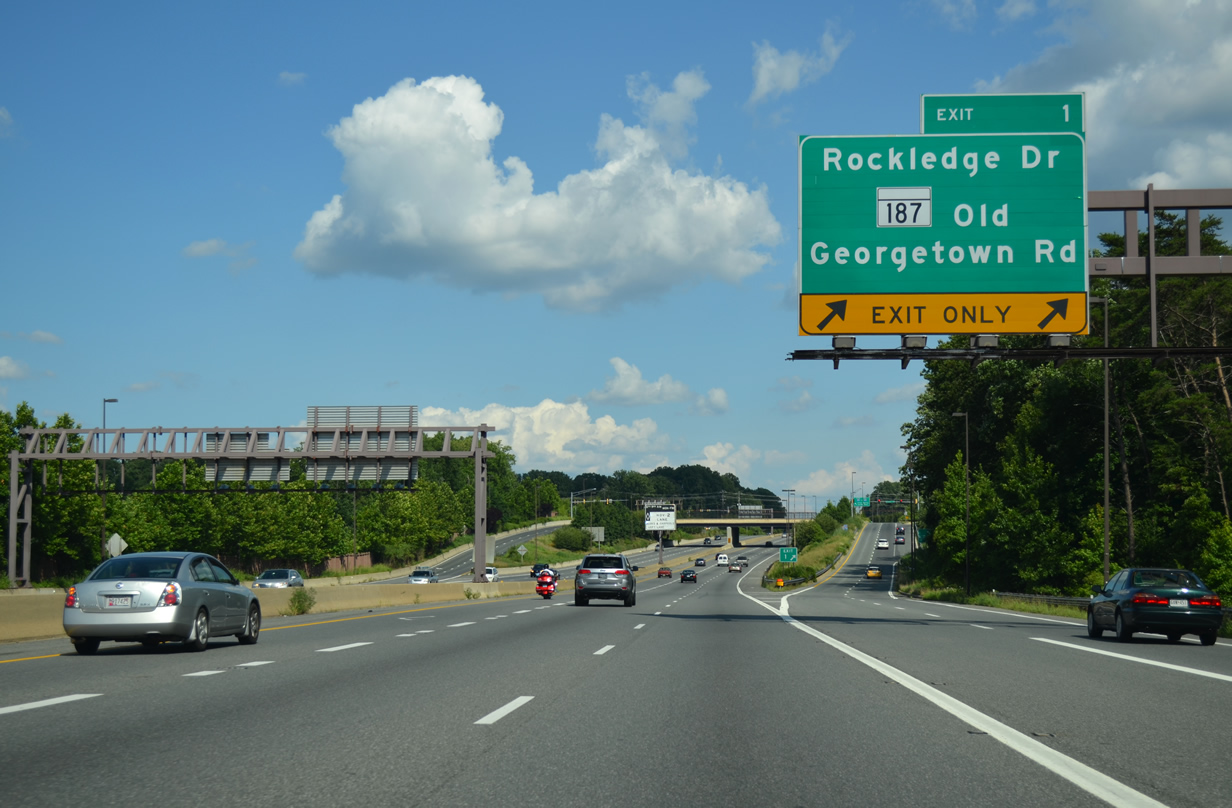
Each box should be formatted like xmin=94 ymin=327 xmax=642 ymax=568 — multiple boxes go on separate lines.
xmin=920 ymin=92 xmax=1087 ymax=138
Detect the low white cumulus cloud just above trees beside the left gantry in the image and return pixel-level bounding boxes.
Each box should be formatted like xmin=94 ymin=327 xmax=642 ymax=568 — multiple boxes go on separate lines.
xmin=420 ymin=399 xmax=668 ymax=473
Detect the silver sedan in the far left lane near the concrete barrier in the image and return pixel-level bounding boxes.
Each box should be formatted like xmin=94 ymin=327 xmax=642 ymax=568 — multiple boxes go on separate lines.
xmin=64 ymin=553 xmax=261 ymax=654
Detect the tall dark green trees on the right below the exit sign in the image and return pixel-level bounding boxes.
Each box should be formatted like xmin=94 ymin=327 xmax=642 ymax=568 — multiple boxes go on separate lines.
xmin=903 ymin=211 xmax=1232 ymax=597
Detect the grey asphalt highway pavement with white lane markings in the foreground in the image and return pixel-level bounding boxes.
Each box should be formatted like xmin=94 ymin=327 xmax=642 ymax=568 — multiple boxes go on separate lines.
xmin=0 ymin=525 xmax=1232 ymax=808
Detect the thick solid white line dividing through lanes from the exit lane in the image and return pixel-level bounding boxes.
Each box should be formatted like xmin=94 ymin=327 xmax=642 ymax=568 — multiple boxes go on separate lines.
xmin=740 ymin=581 xmax=1167 ymax=808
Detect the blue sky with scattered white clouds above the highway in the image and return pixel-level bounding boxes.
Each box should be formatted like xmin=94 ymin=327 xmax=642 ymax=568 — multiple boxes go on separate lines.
xmin=0 ymin=0 xmax=1232 ymax=501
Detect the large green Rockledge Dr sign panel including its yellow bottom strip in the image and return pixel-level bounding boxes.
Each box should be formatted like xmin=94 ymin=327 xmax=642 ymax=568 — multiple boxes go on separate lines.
xmin=798 ymin=132 xmax=1088 ymax=335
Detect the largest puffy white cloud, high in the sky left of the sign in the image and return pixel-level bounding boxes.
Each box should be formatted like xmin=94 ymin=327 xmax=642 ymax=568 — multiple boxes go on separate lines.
xmin=294 ymin=74 xmax=781 ymax=310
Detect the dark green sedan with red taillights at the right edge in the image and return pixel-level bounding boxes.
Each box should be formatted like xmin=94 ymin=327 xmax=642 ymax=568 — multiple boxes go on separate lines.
xmin=1087 ymin=568 xmax=1223 ymax=645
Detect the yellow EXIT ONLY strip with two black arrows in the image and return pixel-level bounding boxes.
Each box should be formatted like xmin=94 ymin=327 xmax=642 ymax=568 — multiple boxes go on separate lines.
xmin=800 ymin=292 xmax=1088 ymax=336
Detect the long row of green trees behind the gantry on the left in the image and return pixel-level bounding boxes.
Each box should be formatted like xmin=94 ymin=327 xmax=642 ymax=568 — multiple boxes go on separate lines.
xmin=0 ymin=402 xmax=777 ymax=583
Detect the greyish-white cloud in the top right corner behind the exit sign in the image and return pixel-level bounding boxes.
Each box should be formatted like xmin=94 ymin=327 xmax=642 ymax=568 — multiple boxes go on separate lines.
xmin=976 ymin=0 xmax=1232 ymax=188
